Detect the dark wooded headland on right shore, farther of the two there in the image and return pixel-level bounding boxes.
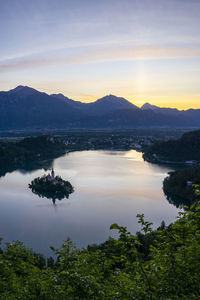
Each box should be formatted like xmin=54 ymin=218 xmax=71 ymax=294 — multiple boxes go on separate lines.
xmin=143 ymin=130 xmax=200 ymax=162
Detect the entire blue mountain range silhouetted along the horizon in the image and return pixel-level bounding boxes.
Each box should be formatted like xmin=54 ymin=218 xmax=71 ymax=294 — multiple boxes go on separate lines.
xmin=0 ymin=86 xmax=200 ymax=130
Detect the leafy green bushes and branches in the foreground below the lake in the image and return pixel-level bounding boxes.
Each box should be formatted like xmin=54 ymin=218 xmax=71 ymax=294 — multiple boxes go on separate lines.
xmin=0 ymin=203 xmax=200 ymax=300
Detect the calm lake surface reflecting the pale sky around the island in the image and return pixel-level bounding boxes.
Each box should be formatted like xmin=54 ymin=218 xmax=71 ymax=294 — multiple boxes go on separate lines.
xmin=0 ymin=150 xmax=177 ymax=255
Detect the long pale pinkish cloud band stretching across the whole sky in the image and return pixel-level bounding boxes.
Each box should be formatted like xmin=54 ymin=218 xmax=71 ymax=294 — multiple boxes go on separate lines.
xmin=0 ymin=46 xmax=200 ymax=73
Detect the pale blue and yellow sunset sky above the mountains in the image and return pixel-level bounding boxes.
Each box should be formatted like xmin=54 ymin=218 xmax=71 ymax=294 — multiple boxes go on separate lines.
xmin=0 ymin=0 xmax=200 ymax=109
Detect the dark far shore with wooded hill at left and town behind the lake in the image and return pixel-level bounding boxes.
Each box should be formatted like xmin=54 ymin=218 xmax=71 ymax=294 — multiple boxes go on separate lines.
xmin=0 ymin=129 xmax=186 ymax=176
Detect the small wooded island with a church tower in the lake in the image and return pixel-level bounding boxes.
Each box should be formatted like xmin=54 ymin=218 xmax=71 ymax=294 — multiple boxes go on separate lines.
xmin=29 ymin=168 xmax=74 ymax=200
